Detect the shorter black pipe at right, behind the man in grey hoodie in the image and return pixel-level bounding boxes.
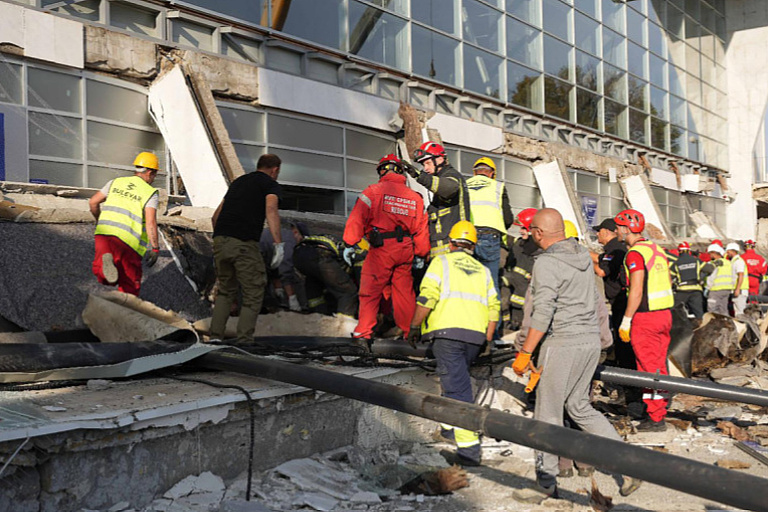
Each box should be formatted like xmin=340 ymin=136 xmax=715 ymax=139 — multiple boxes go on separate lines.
xmin=595 ymin=366 xmax=768 ymax=407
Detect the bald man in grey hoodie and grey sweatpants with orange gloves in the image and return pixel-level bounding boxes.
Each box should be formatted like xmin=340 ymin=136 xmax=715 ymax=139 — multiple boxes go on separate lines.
xmin=512 ymin=208 xmax=641 ymax=503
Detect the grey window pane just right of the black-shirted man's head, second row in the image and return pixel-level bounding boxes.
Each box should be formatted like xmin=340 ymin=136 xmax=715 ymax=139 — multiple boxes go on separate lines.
xmin=279 ymin=149 xmax=342 ymax=187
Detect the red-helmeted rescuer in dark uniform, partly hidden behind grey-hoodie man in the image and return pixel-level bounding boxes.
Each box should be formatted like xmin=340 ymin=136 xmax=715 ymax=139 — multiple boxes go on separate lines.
xmin=505 ymin=208 xmax=539 ymax=331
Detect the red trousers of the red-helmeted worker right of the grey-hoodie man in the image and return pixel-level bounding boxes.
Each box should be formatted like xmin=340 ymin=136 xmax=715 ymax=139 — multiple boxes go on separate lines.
xmin=629 ymin=309 xmax=672 ymax=421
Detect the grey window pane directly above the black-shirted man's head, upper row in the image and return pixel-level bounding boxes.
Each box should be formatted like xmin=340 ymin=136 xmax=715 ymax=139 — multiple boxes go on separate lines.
xmin=267 ymin=115 xmax=342 ymax=154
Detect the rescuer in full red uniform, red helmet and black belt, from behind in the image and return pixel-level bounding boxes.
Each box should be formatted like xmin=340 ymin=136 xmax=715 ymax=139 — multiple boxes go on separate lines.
xmin=344 ymin=154 xmax=430 ymax=347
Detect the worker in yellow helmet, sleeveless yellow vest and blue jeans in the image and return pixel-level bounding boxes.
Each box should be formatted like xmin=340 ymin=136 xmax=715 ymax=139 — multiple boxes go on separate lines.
xmin=467 ymin=157 xmax=515 ymax=338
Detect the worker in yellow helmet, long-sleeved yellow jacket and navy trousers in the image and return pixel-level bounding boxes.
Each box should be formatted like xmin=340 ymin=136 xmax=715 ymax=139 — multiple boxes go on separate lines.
xmin=408 ymin=221 xmax=499 ymax=466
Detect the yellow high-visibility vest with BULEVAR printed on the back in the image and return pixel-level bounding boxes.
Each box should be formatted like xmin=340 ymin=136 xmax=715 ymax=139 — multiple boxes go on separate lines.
xmin=96 ymin=176 xmax=157 ymax=256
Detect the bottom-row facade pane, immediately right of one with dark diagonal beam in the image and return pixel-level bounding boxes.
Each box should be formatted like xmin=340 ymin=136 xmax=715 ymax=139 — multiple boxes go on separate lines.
xmin=411 ymin=25 xmax=459 ymax=85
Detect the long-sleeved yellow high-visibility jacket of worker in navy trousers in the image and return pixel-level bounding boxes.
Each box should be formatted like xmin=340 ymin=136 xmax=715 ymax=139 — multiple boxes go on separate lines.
xmin=417 ymin=251 xmax=500 ymax=345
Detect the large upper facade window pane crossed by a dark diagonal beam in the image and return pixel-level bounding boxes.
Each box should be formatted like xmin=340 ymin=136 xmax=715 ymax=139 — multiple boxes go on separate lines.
xmin=349 ymin=2 xmax=408 ymax=69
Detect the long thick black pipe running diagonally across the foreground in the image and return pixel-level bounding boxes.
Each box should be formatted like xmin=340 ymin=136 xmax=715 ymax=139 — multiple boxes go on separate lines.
xmin=195 ymin=353 xmax=768 ymax=512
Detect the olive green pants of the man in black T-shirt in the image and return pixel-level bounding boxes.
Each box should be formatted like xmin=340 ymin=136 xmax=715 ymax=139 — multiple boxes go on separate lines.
xmin=211 ymin=236 xmax=267 ymax=343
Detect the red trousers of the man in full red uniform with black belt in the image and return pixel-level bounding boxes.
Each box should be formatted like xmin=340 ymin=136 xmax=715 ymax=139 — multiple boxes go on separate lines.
xmin=355 ymin=238 xmax=416 ymax=338
